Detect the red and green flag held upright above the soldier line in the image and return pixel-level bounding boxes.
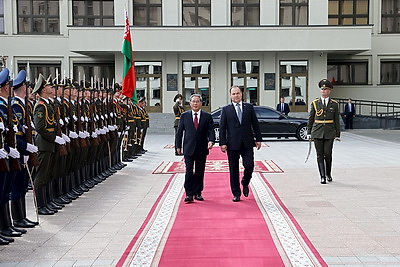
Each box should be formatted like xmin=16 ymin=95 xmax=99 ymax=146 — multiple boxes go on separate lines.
xmin=121 ymin=11 xmax=137 ymax=104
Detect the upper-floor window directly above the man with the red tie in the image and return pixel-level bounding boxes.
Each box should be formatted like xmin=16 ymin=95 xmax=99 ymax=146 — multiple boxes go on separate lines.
xmin=182 ymin=0 xmax=211 ymax=26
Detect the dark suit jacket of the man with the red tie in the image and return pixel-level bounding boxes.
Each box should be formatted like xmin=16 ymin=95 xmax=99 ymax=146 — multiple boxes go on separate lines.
xmin=175 ymin=110 xmax=215 ymax=156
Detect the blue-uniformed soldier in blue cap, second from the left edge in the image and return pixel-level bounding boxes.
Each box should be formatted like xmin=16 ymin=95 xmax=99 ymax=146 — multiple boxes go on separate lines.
xmin=10 ymin=70 xmax=38 ymax=228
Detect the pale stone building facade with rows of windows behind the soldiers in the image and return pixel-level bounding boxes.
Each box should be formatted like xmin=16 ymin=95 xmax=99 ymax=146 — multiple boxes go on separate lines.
xmin=0 ymin=0 xmax=400 ymax=113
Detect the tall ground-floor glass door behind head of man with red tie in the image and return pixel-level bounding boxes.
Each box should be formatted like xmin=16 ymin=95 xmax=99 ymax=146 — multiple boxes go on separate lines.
xmin=182 ymin=61 xmax=211 ymax=111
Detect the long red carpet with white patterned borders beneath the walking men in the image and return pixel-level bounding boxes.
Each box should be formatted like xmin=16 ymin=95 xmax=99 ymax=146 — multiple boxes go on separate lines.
xmin=117 ymin=148 xmax=326 ymax=267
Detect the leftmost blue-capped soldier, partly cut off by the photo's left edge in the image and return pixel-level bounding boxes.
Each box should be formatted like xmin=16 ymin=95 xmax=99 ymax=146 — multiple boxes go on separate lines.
xmin=0 ymin=68 xmax=26 ymax=245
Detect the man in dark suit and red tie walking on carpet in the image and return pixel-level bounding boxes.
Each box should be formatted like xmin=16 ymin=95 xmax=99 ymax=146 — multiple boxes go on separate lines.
xmin=175 ymin=94 xmax=215 ymax=203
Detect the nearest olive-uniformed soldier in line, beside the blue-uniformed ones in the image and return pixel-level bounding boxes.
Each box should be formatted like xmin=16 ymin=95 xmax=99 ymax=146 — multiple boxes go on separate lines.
xmin=32 ymin=74 xmax=65 ymax=215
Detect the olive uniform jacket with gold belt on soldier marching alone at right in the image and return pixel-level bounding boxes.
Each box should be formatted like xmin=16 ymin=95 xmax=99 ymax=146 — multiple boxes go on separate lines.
xmin=308 ymin=98 xmax=340 ymax=139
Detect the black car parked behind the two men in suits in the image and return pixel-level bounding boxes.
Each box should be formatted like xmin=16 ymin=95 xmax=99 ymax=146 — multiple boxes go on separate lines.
xmin=211 ymin=106 xmax=308 ymax=141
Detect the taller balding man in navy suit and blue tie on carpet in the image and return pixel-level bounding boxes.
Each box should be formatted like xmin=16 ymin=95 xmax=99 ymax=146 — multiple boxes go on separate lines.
xmin=219 ymin=86 xmax=262 ymax=202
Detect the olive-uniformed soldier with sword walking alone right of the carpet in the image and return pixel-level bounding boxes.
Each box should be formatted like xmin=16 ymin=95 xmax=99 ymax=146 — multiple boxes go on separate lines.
xmin=308 ymin=79 xmax=340 ymax=184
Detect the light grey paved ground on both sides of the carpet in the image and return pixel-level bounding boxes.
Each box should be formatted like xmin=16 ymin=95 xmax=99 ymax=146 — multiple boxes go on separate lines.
xmin=0 ymin=130 xmax=400 ymax=266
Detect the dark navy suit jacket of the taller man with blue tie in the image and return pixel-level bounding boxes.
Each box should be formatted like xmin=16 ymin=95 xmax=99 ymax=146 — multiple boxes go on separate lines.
xmin=219 ymin=102 xmax=262 ymax=150
